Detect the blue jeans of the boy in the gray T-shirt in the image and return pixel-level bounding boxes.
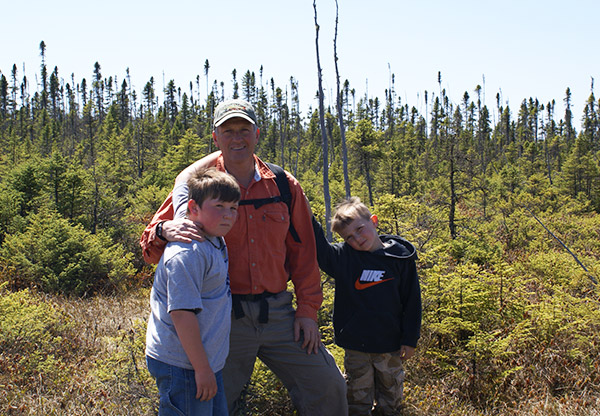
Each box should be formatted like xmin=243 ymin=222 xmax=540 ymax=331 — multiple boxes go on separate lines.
xmin=146 ymin=356 xmax=229 ymax=416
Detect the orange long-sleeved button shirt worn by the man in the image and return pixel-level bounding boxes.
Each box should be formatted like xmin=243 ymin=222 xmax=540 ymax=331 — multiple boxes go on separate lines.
xmin=140 ymin=156 xmax=323 ymax=321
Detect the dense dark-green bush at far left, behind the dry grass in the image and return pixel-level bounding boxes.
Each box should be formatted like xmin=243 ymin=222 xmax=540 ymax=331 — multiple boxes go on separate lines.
xmin=0 ymin=211 xmax=133 ymax=296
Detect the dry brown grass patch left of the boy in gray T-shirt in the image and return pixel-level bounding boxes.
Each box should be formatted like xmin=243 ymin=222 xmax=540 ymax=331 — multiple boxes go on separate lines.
xmin=0 ymin=290 xmax=156 ymax=416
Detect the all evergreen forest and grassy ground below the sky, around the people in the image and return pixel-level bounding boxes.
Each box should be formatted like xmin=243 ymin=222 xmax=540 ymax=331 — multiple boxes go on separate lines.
xmin=0 ymin=42 xmax=600 ymax=415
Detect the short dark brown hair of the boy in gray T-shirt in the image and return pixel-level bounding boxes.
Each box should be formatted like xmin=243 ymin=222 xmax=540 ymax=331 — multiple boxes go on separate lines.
xmin=187 ymin=168 xmax=242 ymax=206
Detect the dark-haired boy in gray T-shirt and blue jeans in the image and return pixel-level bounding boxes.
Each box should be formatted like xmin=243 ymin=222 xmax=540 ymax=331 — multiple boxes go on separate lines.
xmin=146 ymin=168 xmax=241 ymax=416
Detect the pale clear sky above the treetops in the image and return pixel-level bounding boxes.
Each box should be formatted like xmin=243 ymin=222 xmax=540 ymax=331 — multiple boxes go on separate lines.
xmin=0 ymin=0 xmax=600 ymax=129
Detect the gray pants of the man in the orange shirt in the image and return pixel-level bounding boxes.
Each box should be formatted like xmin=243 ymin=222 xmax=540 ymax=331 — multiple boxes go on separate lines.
xmin=223 ymin=292 xmax=348 ymax=416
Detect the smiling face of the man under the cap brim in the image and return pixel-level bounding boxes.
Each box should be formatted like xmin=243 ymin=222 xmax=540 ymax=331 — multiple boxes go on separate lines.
xmin=213 ymin=117 xmax=260 ymax=164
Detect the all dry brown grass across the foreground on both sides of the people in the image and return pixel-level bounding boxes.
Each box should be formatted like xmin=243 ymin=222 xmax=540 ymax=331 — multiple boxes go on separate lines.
xmin=0 ymin=289 xmax=600 ymax=416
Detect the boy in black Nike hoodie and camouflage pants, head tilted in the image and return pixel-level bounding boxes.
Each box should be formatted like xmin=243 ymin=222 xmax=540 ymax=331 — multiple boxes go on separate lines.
xmin=313 ymin=197 xmax=421 ymax=416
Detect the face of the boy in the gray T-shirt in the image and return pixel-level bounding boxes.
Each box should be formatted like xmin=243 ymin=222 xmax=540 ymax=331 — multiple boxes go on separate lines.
xmin=188 ymin=198 xmax=238 ymax=237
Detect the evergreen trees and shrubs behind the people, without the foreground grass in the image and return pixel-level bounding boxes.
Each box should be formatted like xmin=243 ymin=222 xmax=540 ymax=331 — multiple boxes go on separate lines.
xmin=0 ymin=42 xmax=600 ymax=407
